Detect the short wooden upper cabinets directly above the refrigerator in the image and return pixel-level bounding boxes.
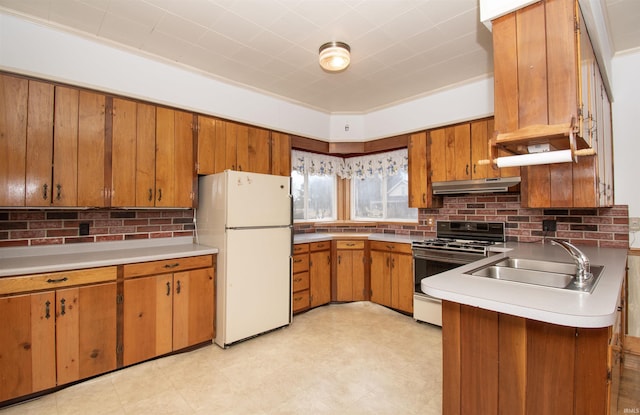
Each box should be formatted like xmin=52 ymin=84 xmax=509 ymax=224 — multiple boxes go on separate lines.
xmin=198 ymin=115 xmax=291 ymax=176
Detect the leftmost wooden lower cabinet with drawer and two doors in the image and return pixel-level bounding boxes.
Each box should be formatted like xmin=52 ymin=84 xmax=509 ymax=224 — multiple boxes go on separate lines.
xmin=0 ymin=267 xmax=117 ymax=402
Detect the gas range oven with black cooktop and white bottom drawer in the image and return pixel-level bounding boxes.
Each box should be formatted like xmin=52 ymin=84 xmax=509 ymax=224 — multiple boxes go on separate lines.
xmin=412 ymin=221 xmax=505 ymax=326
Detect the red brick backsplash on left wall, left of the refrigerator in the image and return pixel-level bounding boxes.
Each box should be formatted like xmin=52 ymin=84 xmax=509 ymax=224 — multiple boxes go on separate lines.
xmin=0 ymin=209 xmax=194 ymax=247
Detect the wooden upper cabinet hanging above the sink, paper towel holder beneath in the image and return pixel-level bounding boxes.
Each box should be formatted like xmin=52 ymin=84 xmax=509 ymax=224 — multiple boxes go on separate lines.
xmin=492 ymin=0 xmax=613 ymax=207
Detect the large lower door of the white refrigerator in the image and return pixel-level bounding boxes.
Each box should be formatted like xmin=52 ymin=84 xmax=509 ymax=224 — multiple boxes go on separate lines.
xmin=217 ymin=228 xmax=291 ymax=345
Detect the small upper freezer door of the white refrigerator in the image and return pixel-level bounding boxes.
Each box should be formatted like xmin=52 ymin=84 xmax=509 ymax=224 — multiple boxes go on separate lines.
xmin=225 ymin=170 xmax=291 ymax=228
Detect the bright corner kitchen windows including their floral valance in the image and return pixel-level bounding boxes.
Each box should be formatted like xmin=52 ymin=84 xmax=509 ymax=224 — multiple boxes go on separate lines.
xmin=291 ymin=149 xmax=418 ymax=222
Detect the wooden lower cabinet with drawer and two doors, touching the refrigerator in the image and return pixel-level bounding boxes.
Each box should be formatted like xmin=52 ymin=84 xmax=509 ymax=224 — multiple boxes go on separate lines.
xmin=123 ymin=255 xmax=214 ymax=366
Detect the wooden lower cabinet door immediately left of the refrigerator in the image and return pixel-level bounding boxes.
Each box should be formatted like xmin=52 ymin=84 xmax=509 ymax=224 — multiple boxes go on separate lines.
xmin=173 ymin=268 xmax=215 ymax=350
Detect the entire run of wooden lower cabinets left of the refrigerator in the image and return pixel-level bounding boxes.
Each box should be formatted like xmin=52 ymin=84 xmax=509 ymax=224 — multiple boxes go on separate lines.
xmin=0 ymin=255 xmax=215 ymax=407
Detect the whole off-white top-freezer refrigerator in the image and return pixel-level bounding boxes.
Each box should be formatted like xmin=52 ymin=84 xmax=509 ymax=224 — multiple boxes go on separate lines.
xmin=196 ymin=170 xmax=292 ymax=348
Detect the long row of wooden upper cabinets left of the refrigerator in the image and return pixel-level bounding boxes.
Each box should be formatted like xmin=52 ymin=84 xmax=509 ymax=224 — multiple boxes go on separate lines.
xmin=0 ymin=74 xmax=196 ymax=208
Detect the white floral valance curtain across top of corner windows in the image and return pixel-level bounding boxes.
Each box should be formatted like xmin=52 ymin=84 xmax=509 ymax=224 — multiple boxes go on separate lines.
xmin=291 ymin=148 xmax=409 ymax=179
